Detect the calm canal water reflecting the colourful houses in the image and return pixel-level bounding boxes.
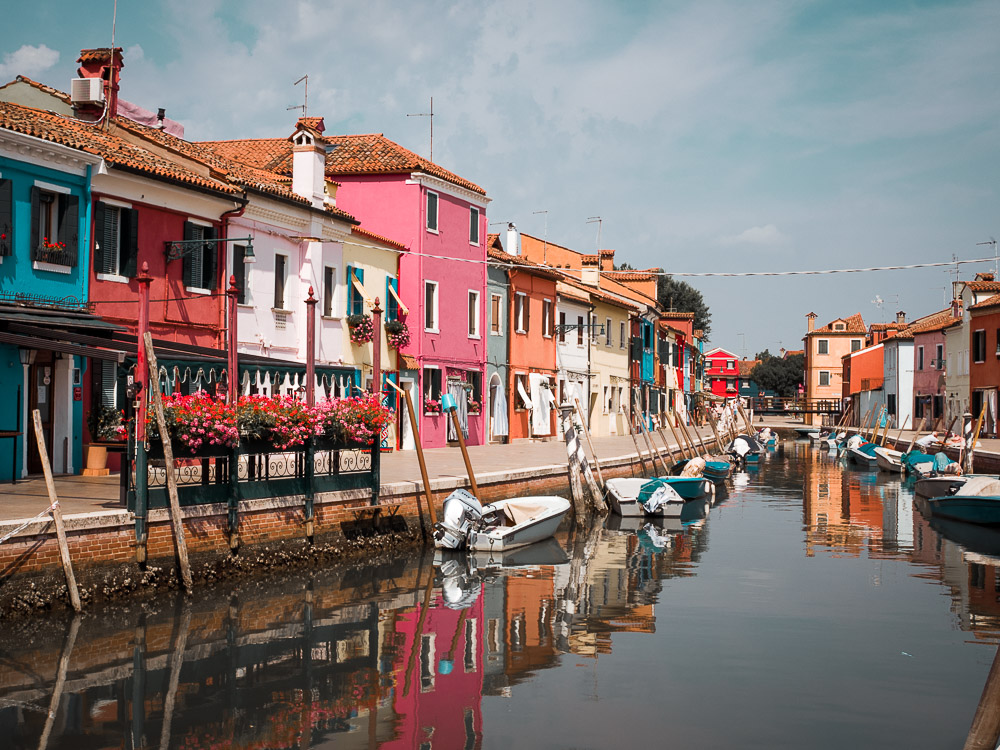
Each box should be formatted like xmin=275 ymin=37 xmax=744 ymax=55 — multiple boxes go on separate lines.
xmin=0 ymin=442 xmax=1000 ymax=750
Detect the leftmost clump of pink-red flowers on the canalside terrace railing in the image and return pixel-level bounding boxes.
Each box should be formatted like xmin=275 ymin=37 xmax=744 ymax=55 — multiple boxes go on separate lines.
xmin=146 ymin=391 xmax=240 ymax=453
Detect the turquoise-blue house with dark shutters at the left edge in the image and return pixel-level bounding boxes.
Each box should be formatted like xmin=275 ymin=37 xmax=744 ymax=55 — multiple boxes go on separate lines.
xmin=0 ymin=120 xmax=113 ymax=481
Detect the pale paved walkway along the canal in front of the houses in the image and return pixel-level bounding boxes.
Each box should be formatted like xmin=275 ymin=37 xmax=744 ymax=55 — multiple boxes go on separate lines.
xmin=0 ymin=418 xmax=1000 ymax=521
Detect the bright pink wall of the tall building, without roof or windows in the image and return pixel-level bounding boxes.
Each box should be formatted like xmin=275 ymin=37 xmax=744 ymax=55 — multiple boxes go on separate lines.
xmin=336 ymin=174 xmax=487 ymax=448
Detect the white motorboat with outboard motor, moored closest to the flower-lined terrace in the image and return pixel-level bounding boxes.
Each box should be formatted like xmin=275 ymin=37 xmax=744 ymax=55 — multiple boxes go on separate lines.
xmin=434 ymin=489 xmax=570 ymax=552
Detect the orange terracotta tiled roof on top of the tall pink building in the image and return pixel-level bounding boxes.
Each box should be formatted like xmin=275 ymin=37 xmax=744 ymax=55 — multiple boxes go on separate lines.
xmin=201 ymin=133 xmax=486 ymax=195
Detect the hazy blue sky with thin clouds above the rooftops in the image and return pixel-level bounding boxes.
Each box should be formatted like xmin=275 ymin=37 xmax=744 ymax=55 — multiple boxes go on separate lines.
xmin=0 ymin=0 xmax=1000 ymax=356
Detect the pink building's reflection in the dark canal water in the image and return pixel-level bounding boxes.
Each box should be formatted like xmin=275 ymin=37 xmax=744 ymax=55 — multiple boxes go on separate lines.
xmin=379 ymin=587 xmax=483 ymax=750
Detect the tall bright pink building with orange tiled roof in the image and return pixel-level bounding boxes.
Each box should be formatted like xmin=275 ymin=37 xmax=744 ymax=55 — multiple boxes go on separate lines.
xmin=199 ymin=133 xmax=489 ymax=448
